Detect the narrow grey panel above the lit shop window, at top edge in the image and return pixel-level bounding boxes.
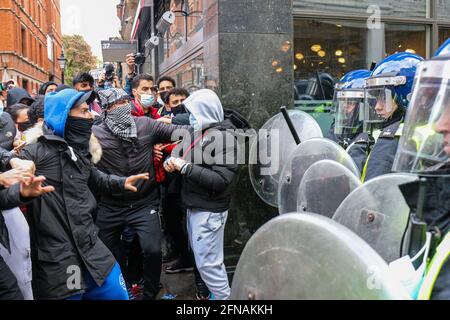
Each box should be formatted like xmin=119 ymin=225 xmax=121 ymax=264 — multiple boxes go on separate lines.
xmin=294 ymin=0 xmax=428 ymax=18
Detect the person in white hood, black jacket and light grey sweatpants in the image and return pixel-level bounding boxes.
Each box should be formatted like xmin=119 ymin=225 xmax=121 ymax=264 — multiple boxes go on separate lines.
xmin=165 ymin=89 xmax=250 ymax=300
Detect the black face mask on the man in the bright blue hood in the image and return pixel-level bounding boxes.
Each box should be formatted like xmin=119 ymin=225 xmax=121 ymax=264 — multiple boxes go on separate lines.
xmin=65 ymin=116 xmax=94 ymax=156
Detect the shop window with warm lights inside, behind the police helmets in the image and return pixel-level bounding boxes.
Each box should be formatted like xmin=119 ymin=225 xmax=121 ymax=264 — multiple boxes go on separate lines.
xmin=294 ymin=19 xmax=427 ymax=101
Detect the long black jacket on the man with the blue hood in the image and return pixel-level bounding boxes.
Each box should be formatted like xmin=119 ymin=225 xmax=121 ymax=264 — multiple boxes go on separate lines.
xmin=16 ymin=131 xmax=125 ymax=299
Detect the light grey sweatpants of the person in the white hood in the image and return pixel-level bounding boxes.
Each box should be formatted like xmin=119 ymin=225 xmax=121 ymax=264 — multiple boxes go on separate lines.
xmin=187 ymin=210 xmax=231 ymax=300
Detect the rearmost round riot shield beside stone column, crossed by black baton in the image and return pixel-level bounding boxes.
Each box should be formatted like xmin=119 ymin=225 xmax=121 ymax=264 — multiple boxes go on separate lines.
xmin=249 ymin=110 xmax=323 ymax=207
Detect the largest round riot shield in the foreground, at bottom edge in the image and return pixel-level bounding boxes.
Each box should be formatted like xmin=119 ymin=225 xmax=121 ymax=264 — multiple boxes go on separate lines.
xmin=231 ymin=213 xmax=408 ymax=300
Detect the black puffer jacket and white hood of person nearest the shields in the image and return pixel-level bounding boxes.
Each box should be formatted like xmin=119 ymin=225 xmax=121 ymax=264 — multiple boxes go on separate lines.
xmin=173 ymin=90 xmax=250 ymax=212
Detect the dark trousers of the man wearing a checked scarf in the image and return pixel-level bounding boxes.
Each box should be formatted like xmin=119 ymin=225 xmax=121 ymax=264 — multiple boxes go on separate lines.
xmin=97 ymin=204 xmax=162 ymax=300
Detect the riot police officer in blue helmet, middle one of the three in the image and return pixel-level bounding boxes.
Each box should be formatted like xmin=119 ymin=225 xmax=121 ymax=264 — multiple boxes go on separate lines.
xmin=362 ymin=52 xmax=423 ymax=181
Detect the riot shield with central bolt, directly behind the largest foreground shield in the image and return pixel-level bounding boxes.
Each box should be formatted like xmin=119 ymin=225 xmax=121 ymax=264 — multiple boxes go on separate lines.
xmin=333 ymin=174 xmax=417 ymax=263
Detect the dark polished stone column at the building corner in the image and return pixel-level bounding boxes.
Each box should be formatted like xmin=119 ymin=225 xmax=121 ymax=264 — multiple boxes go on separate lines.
xmin=204 ymin=0 xmax=294 ymax=245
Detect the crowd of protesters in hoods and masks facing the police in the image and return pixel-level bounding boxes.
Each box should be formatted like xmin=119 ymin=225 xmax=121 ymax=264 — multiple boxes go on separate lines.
xmin=0 ymin=55 xmax=250 ymax=300
